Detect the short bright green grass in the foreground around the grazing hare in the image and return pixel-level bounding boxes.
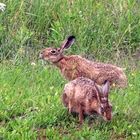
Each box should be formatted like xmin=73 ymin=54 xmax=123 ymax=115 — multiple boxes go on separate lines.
xmin=0 ymin=62 xmax=140 ymax=140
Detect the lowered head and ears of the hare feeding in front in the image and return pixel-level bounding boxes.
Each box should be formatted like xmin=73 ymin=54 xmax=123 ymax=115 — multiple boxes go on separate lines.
xmin=98 ymin=81 xmax=112 ymax=121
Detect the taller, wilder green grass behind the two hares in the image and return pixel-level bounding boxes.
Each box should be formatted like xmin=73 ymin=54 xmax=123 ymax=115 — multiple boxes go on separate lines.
xmin=0 ymin=0 xmax=140 ymax=60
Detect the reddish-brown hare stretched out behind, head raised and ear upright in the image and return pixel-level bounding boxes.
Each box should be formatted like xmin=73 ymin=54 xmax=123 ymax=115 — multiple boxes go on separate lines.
xmin=40 ymin=36 xmax=127 ymax=88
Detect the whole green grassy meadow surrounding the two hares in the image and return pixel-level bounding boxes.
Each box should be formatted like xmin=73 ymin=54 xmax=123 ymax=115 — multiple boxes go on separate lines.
xmin=0 ymin=0 xmax=140 ymax=140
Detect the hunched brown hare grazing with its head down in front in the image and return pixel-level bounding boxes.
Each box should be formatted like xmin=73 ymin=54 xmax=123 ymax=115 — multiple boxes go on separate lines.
xmin=62 ymin=77 xmax=112 ymax=124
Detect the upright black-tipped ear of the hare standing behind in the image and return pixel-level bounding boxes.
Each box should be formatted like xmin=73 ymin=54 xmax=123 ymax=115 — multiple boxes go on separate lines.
xmin=60 ymin=36 xmax=75 ymax=51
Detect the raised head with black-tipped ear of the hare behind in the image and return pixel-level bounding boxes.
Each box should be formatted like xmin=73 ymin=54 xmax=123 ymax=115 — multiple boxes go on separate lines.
xmin=39 ymin=36 xmax=75 ymax=63
